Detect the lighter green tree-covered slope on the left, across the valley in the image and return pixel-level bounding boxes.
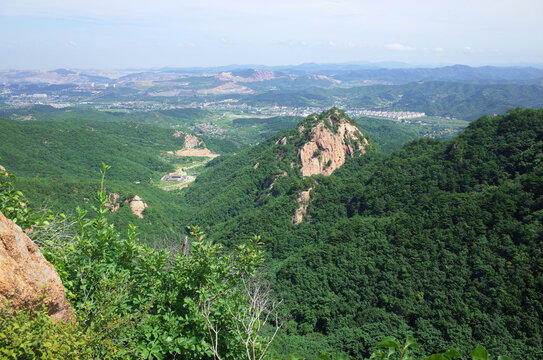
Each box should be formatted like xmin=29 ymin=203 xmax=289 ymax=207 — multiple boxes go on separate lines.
xmin=0 ymin=119 xmax=193 ymax=238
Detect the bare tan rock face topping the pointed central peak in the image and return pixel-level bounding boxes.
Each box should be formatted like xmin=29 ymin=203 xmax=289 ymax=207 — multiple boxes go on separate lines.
xmin=298 ymin=109 xmax=368 ymax=176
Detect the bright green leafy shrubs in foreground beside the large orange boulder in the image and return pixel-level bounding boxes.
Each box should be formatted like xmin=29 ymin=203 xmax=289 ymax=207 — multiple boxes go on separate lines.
xmin=35 ymin=165 xmax=272 ymax=359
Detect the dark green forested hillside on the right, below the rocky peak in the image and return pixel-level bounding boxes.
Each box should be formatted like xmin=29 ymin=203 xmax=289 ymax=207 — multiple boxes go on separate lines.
xmin=185 ymin=109 xmax=543 ymax=359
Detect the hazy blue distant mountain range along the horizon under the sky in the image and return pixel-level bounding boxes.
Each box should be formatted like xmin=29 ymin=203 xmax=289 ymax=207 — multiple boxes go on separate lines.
xmin=0 ymin=62 xmax=543 ymax=85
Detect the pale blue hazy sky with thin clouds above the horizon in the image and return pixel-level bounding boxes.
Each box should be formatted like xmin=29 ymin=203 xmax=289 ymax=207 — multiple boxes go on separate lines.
xmin=0 ymin=0 xmax=543 ymax=69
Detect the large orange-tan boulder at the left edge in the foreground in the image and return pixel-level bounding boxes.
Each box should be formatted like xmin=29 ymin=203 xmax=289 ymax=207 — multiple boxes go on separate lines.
xmin=0 ymin=213 xmax=72 ymax=321
